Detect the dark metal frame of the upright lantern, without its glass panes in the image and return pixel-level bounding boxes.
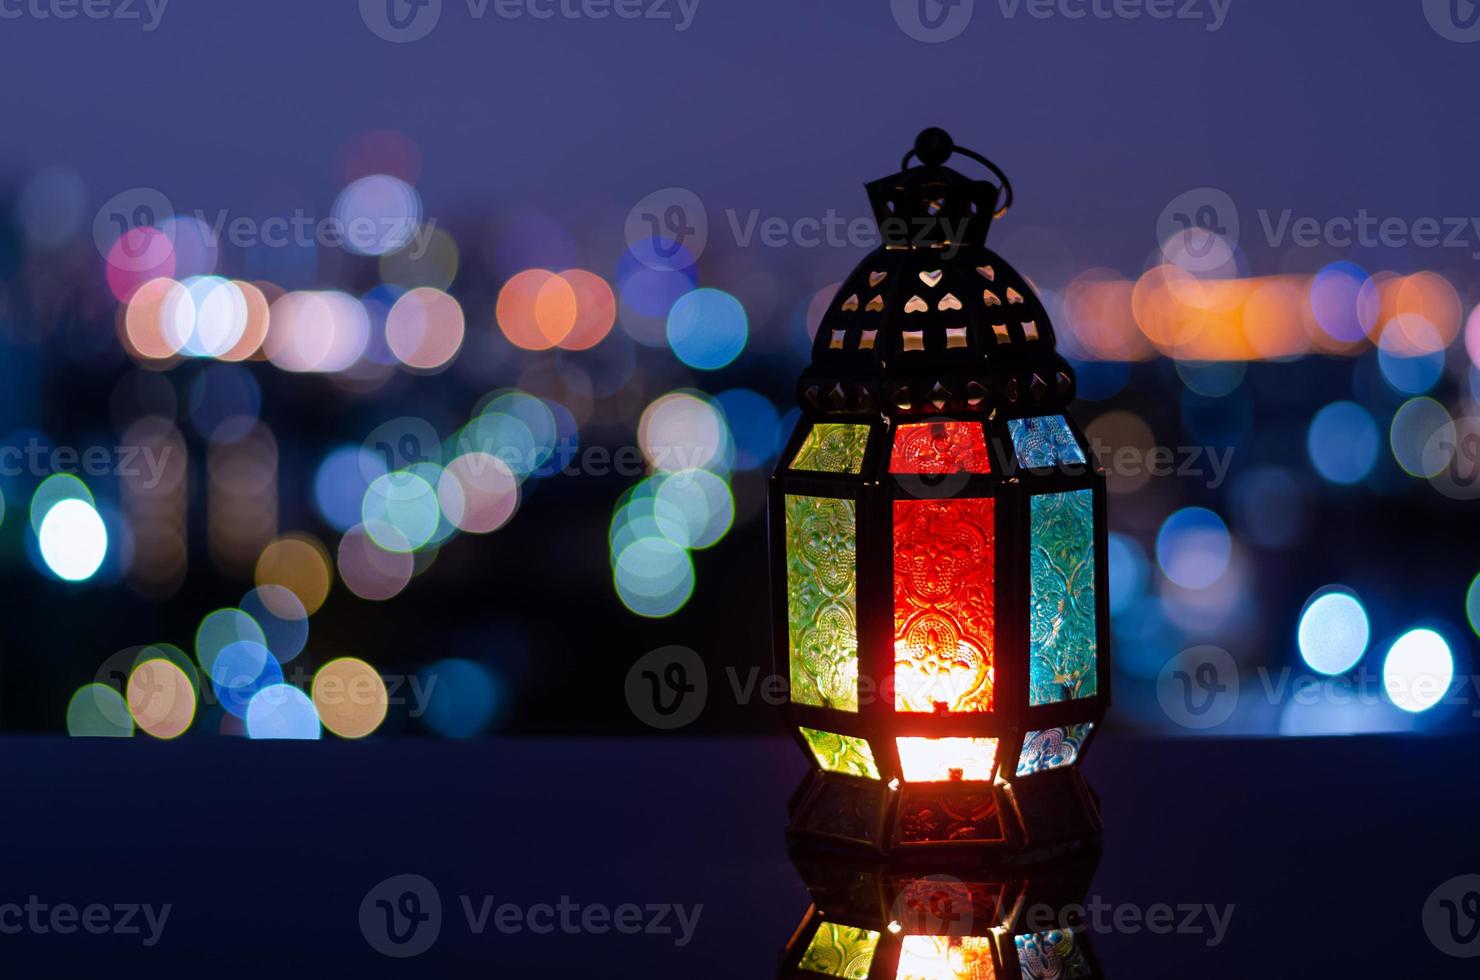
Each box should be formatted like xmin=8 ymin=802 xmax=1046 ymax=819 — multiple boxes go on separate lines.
xmin=768 ymin=130 xmax=1111 ymax=854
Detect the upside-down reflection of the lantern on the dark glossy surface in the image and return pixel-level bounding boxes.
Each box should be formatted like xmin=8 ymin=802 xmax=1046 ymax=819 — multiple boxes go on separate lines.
xmin=778 ymin=848 xmax=1104 ymax=980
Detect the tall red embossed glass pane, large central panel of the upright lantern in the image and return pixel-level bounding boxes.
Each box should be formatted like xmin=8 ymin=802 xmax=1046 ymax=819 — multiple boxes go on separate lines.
xmin=894 ymin=497 xmax=996 ymax=712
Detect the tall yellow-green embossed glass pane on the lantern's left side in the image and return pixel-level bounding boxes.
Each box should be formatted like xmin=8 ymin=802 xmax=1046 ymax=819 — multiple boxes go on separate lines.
xmin=786 ymin=494 xmax=858 ymax=711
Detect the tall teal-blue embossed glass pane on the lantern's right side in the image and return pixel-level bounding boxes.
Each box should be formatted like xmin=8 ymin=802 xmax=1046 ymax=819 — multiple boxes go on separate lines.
xmin=1029 ymin=490 xmax=1098 ymax=705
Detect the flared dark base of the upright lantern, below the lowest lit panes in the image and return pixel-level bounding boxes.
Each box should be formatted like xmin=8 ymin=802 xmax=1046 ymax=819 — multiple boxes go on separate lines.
xmin=787 ymin=767 xmax=1101 ymax=863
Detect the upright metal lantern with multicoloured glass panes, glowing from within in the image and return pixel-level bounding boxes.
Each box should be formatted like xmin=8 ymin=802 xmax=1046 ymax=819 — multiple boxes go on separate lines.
xmin=770 ymin=129 xmax=1110 ymax=853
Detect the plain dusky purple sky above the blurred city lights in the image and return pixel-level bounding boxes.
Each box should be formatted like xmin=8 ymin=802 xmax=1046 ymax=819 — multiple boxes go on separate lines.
xmin=0 ymin=0 xmax=1480 ymax=271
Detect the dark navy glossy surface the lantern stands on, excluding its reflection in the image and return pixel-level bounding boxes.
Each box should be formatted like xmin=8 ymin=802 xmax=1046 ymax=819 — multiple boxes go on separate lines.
xmin=0 ymin=736 xmax=1480 ymax=980
